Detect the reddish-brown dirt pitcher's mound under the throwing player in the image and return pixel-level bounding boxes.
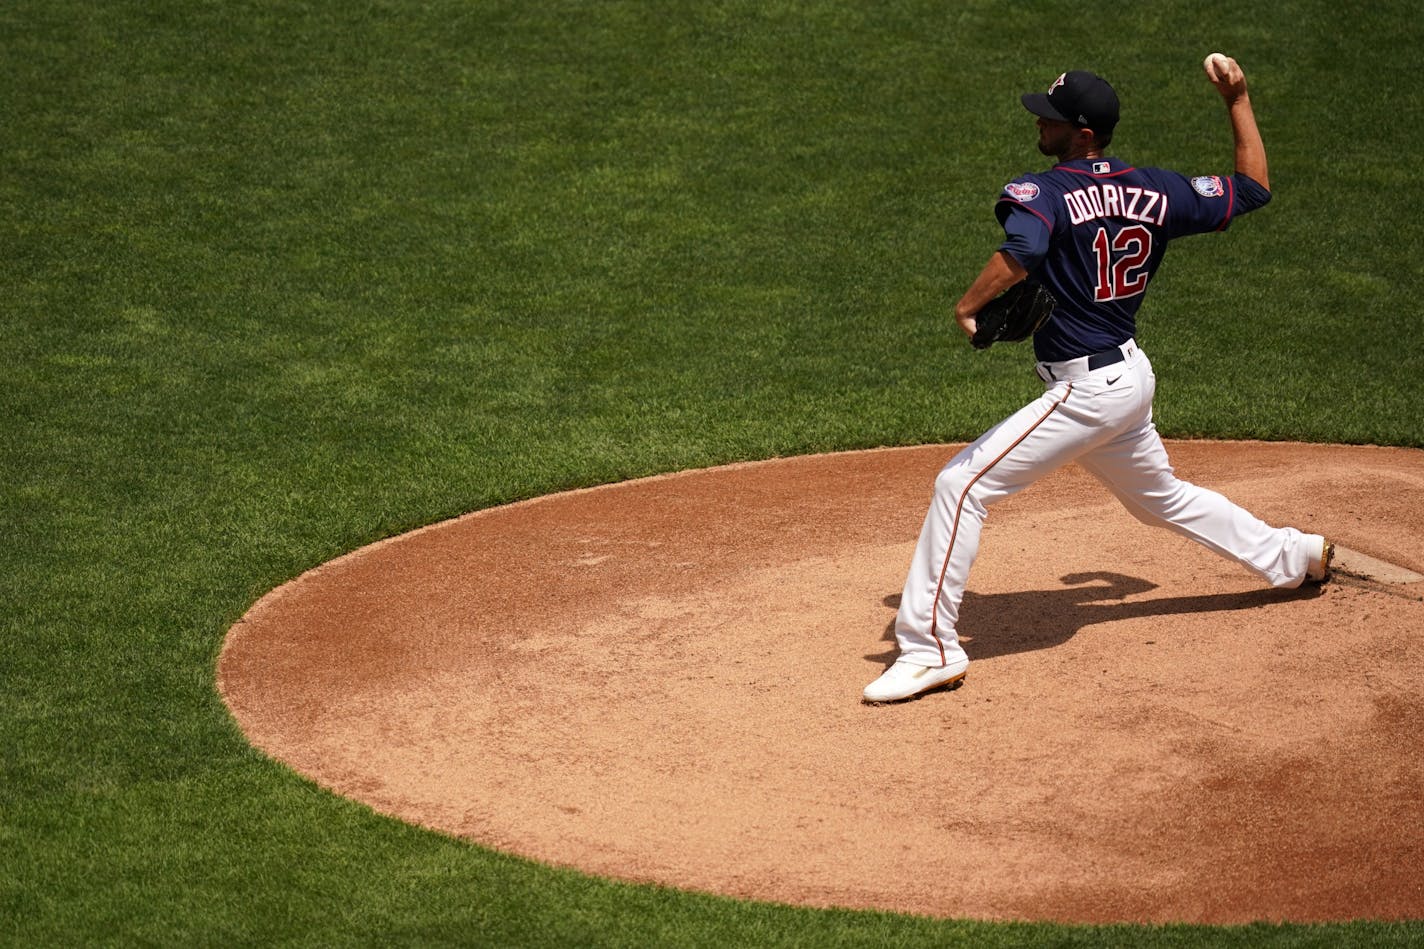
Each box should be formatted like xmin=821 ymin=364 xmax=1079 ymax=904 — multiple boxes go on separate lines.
xmin=219 ymin=442 xmax=1424 ymax=922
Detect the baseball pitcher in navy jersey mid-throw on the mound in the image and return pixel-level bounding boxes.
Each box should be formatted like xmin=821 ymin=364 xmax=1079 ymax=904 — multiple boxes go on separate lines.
xmin=863 ymin=53 xmax=1333 ymax=702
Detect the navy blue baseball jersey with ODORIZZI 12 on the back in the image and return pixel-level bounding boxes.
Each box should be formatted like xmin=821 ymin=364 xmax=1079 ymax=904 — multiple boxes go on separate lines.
xmin=995 ymin=158 xmax=1270 ymax=362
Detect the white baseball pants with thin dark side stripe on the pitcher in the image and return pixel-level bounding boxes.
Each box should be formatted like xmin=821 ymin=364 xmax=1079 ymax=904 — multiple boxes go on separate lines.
xmin=896 ymin=341 xmax=1320 ymax=667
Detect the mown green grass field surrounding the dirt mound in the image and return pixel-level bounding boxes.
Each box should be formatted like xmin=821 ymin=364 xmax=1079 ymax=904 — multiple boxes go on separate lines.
xmin=8 ymin=0 xmax=1424 ymax=946
